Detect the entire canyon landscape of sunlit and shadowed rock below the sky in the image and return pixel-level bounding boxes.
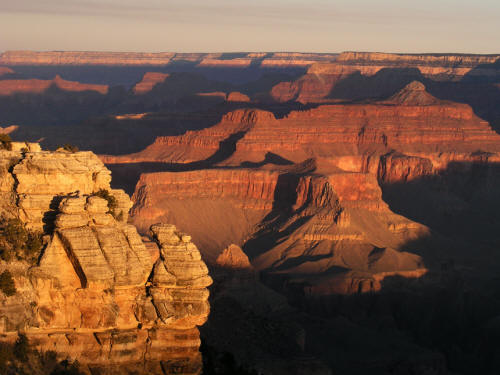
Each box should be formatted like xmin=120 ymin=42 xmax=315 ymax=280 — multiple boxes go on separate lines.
xmin=0 ymin=52 xmax=500 ymax=375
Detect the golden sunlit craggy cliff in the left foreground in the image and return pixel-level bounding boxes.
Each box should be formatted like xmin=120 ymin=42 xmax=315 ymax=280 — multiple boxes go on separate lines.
xmin=0 ymin=146 xmax=212 ymax=374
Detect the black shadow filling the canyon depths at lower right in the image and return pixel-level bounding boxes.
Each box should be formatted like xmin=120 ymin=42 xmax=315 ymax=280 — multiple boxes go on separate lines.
xmin=202 ymin=162 xmax=500 ymax=375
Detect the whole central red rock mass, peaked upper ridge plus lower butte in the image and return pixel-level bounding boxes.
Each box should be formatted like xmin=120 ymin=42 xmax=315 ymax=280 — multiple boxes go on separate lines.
xmin=104 ymin=82 xmax=500 ymax=295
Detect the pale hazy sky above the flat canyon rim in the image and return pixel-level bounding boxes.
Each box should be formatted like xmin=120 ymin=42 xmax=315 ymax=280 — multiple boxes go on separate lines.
xmin=0 ymin=0 xmax=500 ymax=53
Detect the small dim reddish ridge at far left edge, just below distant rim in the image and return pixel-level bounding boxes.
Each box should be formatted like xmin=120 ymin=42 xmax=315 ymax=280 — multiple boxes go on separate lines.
xmin=0 ymin=75 xmax=108 ymax=95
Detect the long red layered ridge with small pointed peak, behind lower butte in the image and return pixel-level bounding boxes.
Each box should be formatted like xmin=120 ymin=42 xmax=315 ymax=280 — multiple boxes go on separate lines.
xmin=102 ymin=86 xmax=500 ymax=181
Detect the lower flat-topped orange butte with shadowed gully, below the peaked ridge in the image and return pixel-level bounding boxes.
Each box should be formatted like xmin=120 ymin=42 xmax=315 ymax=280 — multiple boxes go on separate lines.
xmin=132 ymin=169 xmax=428 ymax=294
